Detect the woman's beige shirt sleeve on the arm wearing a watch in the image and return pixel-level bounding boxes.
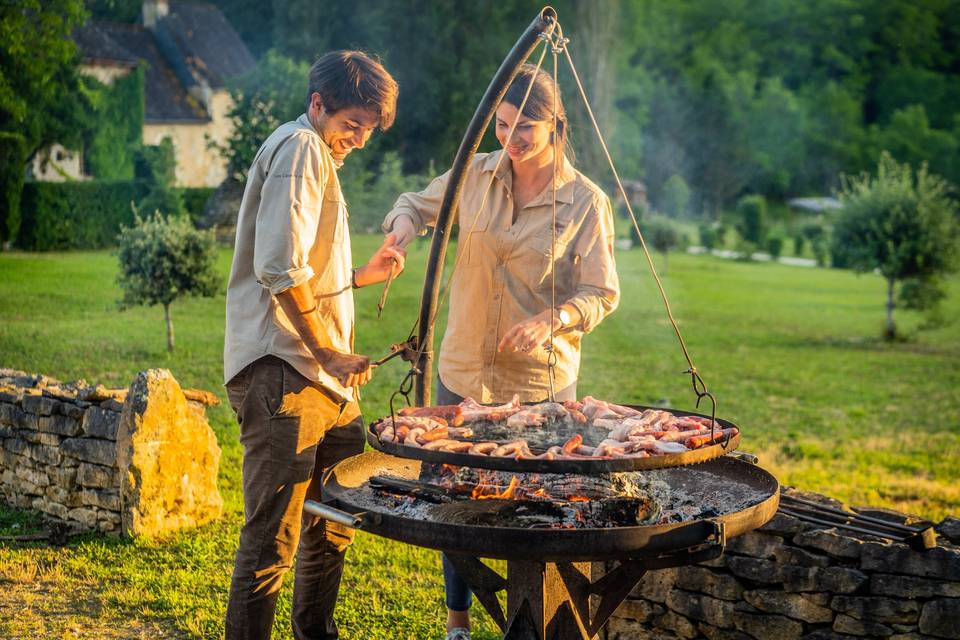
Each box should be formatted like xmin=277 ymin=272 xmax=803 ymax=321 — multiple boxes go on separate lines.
xmin=566 ymin=195 xmax=620 ymax=333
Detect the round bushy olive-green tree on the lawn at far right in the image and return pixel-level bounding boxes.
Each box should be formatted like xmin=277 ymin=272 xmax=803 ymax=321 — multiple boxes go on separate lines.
xmin=834 ymin=152 xmax=960 ymax=339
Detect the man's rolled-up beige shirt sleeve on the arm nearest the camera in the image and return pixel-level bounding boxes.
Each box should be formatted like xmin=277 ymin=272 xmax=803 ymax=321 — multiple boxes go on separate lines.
xmin=253 ymin=135 xmax=328 ymax=295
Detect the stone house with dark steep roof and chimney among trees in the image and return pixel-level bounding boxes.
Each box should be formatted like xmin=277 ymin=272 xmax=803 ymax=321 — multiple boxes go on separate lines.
xmin=28 ymin=0 xmax=256 ymax=187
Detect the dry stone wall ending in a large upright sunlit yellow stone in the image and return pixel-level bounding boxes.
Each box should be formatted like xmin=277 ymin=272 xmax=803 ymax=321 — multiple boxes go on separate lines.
xmin=0 ymin=369 xmax=222 ymax=536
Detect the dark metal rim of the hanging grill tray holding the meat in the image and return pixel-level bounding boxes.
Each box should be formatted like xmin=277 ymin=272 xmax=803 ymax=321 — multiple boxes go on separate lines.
xmin=367 ymin=405 xmax=740 ymax=475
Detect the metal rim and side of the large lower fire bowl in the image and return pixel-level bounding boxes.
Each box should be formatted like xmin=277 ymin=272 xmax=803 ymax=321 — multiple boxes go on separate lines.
xmin=323 ymin=451 xmax=780 ymax=562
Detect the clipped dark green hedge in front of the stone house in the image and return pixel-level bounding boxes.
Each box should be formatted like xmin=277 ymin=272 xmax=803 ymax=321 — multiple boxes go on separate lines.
xmin=16 ymin=181 xmax=149 ymax=251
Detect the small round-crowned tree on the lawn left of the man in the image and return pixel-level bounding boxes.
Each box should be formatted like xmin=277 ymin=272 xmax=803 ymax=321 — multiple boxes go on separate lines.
xmin=117 ymin=211 xmax=219 ymax=351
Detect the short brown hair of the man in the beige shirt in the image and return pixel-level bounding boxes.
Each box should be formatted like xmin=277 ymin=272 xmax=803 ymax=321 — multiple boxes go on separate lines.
xmin=307 ymin=51 xmax=400 ymax=131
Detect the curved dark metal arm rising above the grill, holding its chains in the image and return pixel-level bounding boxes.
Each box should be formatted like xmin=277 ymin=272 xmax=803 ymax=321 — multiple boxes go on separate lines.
xmin=416 ymin=7 xmax=557 ymax=407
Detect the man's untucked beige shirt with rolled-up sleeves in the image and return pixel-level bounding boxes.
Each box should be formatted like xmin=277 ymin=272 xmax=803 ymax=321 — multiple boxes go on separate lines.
xmin=223 ymin=114 xmax=354 ymax=400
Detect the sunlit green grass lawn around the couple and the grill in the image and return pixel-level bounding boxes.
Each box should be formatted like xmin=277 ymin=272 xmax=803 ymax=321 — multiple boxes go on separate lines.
xmin=0 ymin=237 xmax=960 ymax=640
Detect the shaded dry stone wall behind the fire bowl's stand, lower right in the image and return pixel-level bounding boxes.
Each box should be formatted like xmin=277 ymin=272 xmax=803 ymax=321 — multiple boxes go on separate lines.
xmin=605 ymin=492 xmax=960 ymax=640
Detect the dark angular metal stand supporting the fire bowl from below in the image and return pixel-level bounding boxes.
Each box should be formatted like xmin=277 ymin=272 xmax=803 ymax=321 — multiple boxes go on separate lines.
xmin=447 ymin=554 xmax=646 ymax=640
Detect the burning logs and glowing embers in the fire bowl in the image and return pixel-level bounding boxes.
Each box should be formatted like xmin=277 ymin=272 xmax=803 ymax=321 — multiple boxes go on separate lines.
xmin=371 ymin=463 xmax=666 ymax=529
